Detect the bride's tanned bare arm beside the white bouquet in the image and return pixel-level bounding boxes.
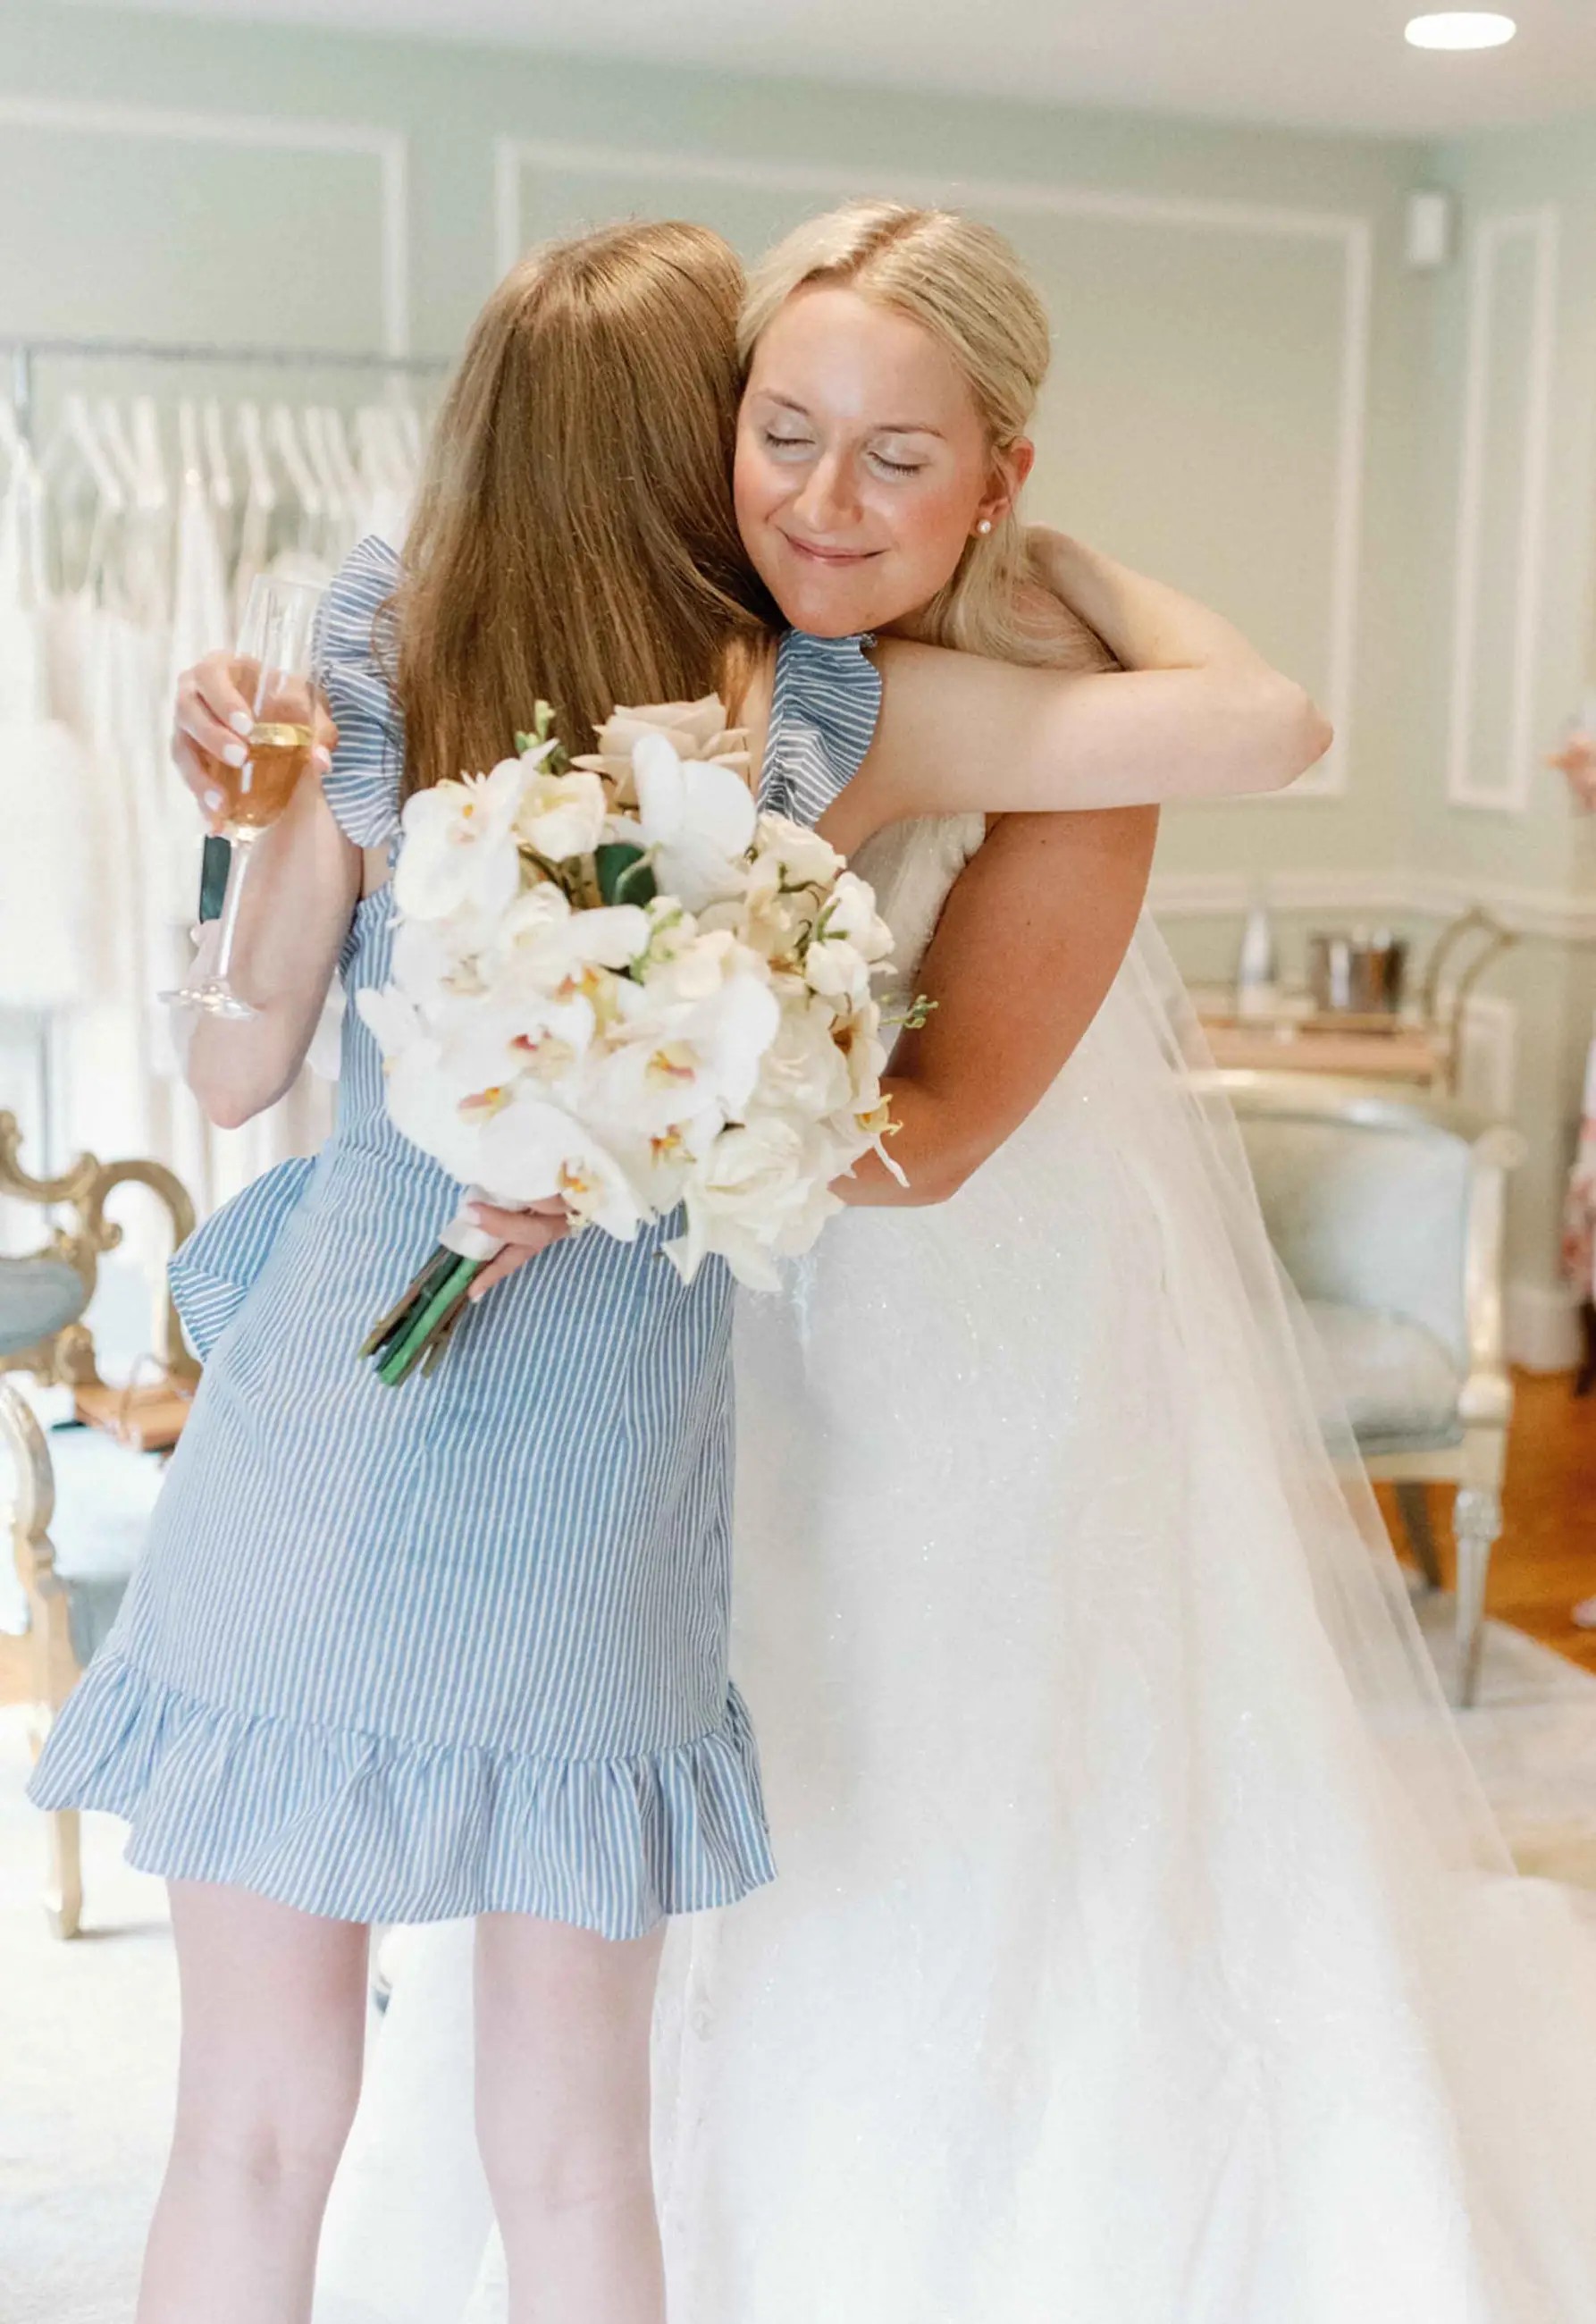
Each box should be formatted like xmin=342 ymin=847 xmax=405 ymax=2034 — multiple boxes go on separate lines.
xmin=836 ymin=806 xmax=1159 ymax=1204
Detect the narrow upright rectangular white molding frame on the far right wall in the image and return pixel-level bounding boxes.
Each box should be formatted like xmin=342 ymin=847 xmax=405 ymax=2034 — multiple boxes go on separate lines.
xmin=1448 ymin=202 xmax=1558 ymax=816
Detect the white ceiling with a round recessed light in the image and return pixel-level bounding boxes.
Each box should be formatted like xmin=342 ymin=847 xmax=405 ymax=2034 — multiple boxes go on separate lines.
xmin=40 ymin=0 xmax=1596 ymax=142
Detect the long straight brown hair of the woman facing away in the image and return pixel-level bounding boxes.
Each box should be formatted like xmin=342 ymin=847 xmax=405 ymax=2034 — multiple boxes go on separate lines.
xmin=392 ymin=221 xmax=781 ymax=795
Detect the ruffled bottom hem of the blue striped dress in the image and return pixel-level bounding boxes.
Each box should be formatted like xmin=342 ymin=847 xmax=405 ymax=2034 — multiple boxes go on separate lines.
xmin=28 ymin=1653 xmax=776 ymax=1938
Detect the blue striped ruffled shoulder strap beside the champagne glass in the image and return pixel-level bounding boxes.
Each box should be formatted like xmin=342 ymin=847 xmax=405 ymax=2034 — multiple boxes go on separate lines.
xmin=314 ymin=535 xmax=404 ymax=848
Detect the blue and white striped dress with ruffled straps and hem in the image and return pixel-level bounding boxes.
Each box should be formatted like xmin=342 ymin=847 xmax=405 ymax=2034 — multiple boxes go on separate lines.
xmin=30 ymin=542 xmax=878 ymax=1938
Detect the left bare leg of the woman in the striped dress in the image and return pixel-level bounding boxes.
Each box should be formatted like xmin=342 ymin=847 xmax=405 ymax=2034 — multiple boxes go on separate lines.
xmin=137 ymin=1880 xmax=367 ymax=2324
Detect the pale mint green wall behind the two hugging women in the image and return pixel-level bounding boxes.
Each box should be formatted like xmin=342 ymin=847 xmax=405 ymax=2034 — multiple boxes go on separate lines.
xmin=0 ymin=0 xmax=1596 ymax=1348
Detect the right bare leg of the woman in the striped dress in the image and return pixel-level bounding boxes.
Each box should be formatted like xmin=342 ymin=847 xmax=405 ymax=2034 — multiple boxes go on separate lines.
xmin=476 ymin=1913 xmax=665 ymax=2324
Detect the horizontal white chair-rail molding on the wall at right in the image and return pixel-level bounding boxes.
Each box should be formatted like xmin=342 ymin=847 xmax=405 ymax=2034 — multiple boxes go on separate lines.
xmin=1147 ymin=869 xmax=1596 ymax=944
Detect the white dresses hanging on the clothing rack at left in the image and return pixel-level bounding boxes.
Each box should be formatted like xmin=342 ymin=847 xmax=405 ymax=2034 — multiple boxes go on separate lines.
xmin=0 ymin=333 xmax=450 ymax=1292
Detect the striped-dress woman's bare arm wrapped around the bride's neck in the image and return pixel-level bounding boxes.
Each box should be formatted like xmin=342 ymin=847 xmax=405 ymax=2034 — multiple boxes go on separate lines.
xmin=820 ymin=530 xmax=1331 ymax=853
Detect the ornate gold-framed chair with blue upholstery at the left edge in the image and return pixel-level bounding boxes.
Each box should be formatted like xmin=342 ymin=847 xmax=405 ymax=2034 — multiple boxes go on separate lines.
xmin=0 ymin=1113 xmax=200 ymax=1936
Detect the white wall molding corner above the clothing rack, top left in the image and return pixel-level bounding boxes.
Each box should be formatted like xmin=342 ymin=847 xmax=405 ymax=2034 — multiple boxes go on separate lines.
xmin=0 ymin=96 xmax=411 ymax=356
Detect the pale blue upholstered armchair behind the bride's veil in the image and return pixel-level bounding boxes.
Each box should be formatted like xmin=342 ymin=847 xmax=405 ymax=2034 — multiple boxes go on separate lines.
xmin=1198 ymin=1069 xmax=1524 ymax=1705
